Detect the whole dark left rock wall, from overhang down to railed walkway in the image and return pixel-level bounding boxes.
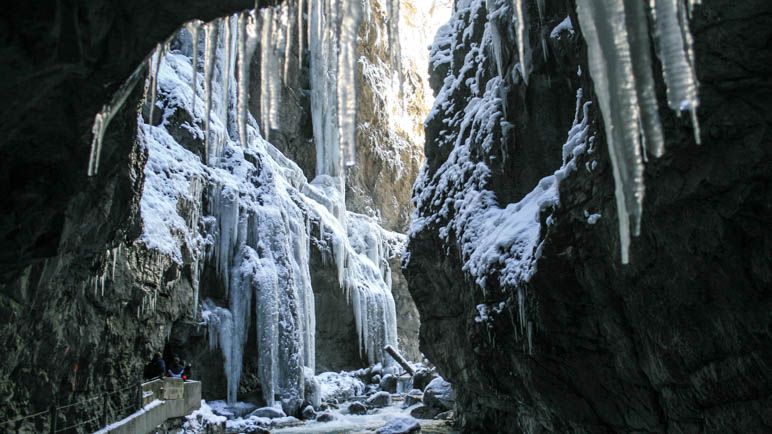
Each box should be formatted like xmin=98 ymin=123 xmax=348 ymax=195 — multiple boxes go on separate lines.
xmin=0 ymin=0 xmax=254 ymax=419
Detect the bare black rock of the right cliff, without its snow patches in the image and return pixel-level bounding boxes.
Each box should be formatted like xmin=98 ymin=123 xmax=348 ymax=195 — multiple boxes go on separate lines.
xmin=403 ymin=0 xmax=772 ymax=432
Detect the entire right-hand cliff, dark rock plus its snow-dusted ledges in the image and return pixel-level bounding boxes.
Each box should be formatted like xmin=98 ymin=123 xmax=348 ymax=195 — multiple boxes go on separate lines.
xmin=403 ymin=0 xmax=772 ymax=432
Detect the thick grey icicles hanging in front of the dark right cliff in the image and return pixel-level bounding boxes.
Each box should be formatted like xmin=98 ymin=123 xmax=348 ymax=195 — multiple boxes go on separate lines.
xmin=576 ymin=0 xmax=699 ymax=264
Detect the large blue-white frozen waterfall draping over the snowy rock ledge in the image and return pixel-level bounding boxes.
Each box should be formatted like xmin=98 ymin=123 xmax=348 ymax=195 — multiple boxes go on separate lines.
xmin=139 ymin=2 xmax=404 ymax=405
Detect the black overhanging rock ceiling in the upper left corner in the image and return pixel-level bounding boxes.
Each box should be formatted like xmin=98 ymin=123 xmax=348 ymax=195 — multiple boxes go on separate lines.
xmin=0 ymin=0 xmax=258 ymax=282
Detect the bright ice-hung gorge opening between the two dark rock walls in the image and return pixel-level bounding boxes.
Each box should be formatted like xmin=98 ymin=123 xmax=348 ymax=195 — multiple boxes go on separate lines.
xmin=123 ymin=1 xmax=451 ymax=423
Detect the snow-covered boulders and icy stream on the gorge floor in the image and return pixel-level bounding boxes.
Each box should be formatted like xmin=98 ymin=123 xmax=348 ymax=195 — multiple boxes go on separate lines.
xmin=178 ymin=367 xmax=458 ymax=434
